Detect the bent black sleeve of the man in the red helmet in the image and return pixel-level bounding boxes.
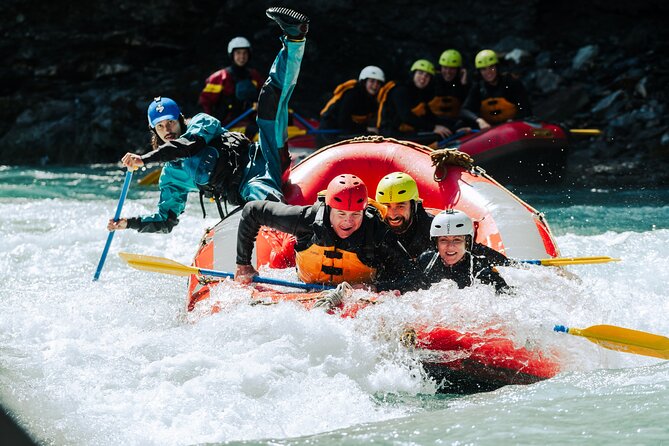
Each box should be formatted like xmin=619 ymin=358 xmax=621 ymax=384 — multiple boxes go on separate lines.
xmin=236 ymin=200 xmax=315 ymax=265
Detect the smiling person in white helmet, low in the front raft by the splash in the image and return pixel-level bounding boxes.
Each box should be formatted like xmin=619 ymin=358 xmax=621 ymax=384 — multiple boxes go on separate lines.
xmin=418 ymin=209 xmax=510 ymax=293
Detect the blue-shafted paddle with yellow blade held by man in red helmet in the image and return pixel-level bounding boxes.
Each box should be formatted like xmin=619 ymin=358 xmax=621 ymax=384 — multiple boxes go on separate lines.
xmin=118 ymin=252 xmax=333 ymax=290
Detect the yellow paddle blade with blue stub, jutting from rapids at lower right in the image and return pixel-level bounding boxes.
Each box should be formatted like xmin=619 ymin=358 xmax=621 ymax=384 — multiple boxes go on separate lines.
xmin=553 ymin=325 xmax=669 ymax=359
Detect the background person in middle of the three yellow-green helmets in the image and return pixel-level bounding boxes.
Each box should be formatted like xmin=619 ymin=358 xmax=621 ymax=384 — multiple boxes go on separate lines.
xmin=429 ymin=49 xmax=471 ymax=126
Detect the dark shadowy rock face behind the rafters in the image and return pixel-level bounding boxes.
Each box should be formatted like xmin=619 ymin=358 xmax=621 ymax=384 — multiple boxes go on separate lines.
xmin=0 ymin=0 xmax=669 ymax=185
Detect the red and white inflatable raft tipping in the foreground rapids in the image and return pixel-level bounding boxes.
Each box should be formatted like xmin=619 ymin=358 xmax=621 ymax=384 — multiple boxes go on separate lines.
xmin=188 ymin=137 xmax=559 ymax=393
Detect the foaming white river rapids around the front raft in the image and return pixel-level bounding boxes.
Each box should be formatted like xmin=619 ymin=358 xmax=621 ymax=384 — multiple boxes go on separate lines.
xmin=0 ymin=169 xmax=669 ymax=445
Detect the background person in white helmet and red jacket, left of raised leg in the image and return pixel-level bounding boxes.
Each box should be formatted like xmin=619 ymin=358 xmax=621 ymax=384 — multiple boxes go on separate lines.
xmin=198 ymin=37 xmax=263 ymax=131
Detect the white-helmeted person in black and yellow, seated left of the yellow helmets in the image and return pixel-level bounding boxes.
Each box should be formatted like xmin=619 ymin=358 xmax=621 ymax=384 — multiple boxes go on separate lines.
xmin=318 ymin=65 xmax=386 ymax=146
